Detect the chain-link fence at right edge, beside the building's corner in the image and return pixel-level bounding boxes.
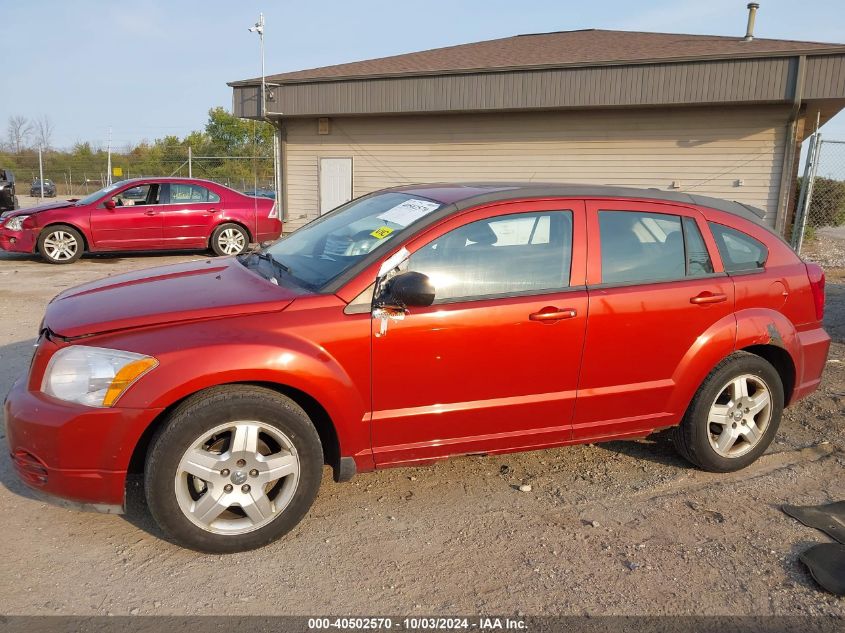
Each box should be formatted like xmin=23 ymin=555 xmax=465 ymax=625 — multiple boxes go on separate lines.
xmin=792 ymin=134 xmax=845 ymax=267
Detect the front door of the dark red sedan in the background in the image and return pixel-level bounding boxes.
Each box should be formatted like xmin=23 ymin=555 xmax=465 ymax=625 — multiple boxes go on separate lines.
xmin=91 ymin=183 xmax=162 ymax=250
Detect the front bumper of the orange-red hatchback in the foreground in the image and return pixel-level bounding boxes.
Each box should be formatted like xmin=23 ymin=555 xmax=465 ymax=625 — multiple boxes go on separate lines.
xmin=4 ymin=379 xmax=161 ymax=508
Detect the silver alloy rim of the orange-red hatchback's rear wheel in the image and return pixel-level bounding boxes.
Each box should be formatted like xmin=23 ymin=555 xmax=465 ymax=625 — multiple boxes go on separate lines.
xmin=707 ymin=374 xmax=772 ymax=458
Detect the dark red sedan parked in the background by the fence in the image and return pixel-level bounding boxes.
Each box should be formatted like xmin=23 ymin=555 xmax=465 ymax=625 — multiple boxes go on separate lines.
xmin=0 ymin=178 xmax=282 ymax=264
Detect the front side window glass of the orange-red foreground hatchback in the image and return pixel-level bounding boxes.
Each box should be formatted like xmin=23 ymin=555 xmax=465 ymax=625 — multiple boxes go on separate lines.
xmin=407 ymin=211 xmax=572 ymax=304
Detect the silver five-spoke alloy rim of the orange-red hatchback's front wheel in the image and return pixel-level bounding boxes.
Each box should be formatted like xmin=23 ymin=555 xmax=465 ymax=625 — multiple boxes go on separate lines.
xmin=175 ymin=421 xmax=301 ymax=535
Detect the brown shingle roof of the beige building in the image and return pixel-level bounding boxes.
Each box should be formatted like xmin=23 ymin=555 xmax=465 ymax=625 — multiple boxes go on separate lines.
xmin=249 ymin=29 xmax=845 ymax=83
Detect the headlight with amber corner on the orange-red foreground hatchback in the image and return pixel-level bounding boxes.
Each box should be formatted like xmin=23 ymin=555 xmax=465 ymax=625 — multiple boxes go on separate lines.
xmin=41 ymin=345 xmax=158 ymax=407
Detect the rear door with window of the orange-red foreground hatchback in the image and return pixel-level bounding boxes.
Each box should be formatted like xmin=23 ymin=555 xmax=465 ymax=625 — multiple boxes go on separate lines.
xmin=573 ymin=200 xmax=735 ymax=440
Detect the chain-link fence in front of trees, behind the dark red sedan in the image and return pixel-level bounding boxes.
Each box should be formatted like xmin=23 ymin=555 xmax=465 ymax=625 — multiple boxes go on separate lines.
xmin=0 ymin=152 xmax=275 ymax=203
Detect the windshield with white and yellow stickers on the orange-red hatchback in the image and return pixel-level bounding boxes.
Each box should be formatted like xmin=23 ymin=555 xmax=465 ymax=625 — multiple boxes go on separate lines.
xmin=258 ymin=192 xmax=442 ymax=289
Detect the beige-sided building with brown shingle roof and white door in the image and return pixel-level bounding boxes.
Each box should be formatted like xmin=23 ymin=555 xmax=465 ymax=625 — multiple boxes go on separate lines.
xmin=230 ymin=30 xmax=845 ymax=231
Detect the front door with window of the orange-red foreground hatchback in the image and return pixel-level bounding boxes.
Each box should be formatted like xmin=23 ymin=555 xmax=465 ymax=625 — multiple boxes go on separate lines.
xmin=372 ymin=200 xmax=587 ymax=465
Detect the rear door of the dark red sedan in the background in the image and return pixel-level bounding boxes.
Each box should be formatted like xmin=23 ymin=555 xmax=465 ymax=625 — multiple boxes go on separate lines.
xmin=162 ymin=182 xmax=221 ymax=248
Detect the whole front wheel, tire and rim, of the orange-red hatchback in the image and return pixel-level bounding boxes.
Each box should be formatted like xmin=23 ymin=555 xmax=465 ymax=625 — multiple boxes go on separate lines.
xmin=144 ymin=385 xmax=323 ymax=554
